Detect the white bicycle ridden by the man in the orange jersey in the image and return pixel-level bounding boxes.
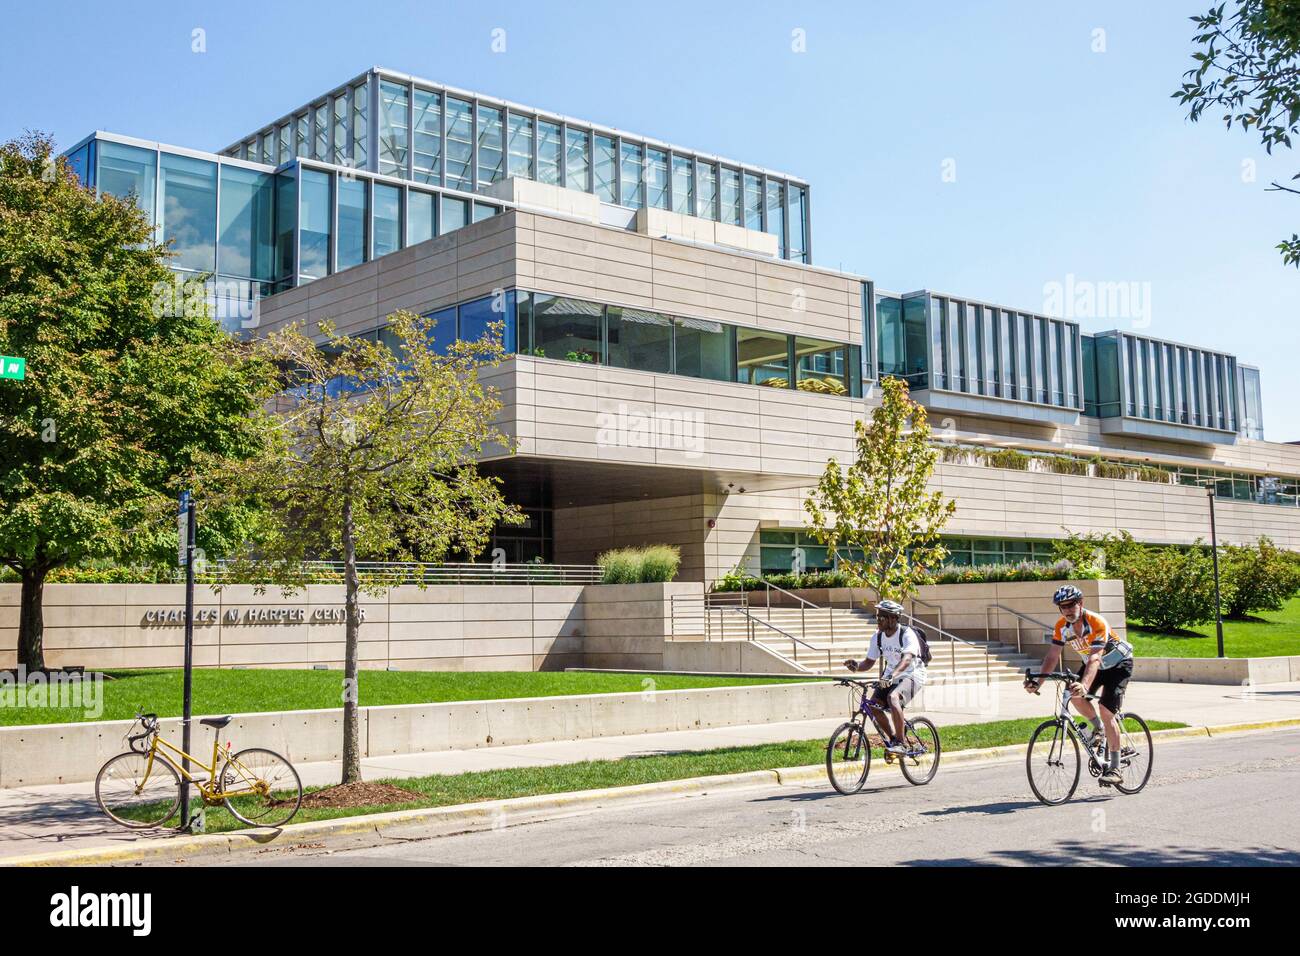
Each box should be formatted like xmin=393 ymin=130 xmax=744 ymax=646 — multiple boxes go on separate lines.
xmin=1024 ymin=670 xmax=1153 ymax=806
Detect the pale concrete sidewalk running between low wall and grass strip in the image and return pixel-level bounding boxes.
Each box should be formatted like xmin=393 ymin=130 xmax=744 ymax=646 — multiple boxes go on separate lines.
xmin=0 ymin=683 xmax=1300 ymax=858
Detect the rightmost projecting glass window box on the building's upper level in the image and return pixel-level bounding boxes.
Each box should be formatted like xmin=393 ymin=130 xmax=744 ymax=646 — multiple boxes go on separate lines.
xmin=1083 ymin=332 xmax=1237 ymax=432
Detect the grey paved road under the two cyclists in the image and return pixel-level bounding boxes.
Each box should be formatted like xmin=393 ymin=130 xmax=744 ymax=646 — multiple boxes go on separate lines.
xmin=192 ymin=731 xmax=1300 ymax=866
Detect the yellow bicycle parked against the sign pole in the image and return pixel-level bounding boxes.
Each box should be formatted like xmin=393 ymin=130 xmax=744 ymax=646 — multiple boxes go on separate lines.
xmin=95 ymin=714 xmax=303 ymax=830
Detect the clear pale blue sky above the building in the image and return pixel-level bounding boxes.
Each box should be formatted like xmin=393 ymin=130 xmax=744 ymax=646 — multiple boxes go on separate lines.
xmin=0 ymin=0 xmax=1300 ymax=441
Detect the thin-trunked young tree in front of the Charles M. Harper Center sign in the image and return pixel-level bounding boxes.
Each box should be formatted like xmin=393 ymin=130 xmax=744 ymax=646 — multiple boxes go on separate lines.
xmin=200 ymin=312 xmax=523 ymax=783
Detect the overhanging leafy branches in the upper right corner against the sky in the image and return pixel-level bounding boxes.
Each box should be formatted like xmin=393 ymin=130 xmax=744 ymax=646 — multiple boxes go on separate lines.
xmin=1173 ymin=0 xmax=1300 ymax=267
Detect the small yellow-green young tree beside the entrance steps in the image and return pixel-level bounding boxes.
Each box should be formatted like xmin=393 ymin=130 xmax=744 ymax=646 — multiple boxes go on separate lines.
xmin=803 ymin=377 xmax=957 ymax=600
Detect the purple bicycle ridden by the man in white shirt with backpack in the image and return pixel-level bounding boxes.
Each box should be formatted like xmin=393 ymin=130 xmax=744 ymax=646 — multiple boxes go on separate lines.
xmin=826 ymin=678 xmax=943 ymax=796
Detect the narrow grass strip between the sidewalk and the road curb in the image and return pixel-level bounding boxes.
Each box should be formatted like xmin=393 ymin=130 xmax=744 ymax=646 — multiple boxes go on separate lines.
xmin=147 ymin=715 xmax=1187 ymax=832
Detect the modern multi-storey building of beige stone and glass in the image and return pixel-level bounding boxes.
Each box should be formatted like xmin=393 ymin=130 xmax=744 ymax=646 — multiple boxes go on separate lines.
xmin=53 ymin=68 xmax=1300 ymax=580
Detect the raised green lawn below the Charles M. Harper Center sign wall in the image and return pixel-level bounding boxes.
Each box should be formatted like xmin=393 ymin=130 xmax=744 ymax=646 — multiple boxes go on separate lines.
xmin=0 ymin=669 xmax=807 ymax=726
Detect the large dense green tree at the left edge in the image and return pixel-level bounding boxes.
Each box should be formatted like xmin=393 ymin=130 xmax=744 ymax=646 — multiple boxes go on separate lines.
xmin=0 ymin=134 xmax=269 ymax=670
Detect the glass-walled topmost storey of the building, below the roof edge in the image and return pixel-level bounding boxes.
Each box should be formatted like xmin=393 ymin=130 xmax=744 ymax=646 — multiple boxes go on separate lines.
xmin=233 ymin=71 xmax=809 ymax=261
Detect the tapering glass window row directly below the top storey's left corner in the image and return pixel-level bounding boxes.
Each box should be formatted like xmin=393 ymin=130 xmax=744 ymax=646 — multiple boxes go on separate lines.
xmin=298 ymin=166 xmax=501 ymax=282
